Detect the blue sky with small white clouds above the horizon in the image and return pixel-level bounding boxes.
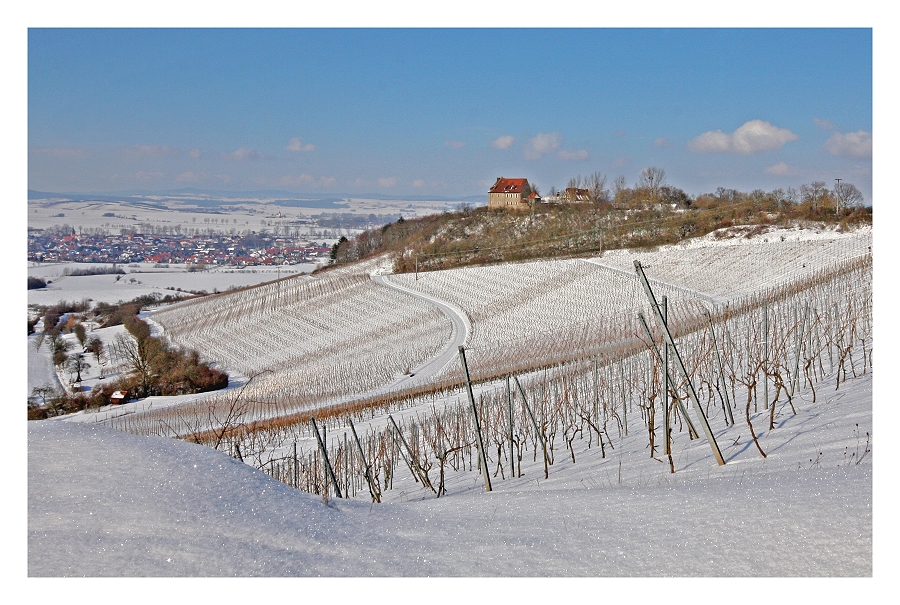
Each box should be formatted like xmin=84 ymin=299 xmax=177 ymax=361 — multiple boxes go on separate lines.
xmin=27 ymin=28 xmax=873 ymax=203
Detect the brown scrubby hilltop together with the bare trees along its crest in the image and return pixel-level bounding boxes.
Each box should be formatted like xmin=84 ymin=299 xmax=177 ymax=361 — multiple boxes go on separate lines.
xmin=324 ymin=167 xmax=872 ymax=273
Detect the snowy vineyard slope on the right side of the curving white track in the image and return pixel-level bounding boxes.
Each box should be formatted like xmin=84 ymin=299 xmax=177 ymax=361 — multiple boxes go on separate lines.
xmin=390 ymin=224 xmax=872 ymax=374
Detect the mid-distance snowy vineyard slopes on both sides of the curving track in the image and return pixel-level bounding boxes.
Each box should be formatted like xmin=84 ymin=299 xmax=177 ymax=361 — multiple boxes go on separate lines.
xmin=132 ymin=223 xmax=872 ymax=434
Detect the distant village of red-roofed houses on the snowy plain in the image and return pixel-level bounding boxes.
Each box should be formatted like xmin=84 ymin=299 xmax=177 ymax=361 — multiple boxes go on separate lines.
xmin=28 ymin=229 xmax=331 ymax=267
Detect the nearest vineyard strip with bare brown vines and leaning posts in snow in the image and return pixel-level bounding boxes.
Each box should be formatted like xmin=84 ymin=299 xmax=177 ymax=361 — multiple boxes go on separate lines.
xmin=110 ymin=225 xmax=873 ymax=518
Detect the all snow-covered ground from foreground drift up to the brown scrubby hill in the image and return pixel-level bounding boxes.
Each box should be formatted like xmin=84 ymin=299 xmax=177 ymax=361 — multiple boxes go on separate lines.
xmin=28 ymin=223 xmax=875 ymax=580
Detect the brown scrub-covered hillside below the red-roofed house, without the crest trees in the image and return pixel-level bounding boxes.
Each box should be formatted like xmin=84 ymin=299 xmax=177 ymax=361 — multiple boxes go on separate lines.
xmin=334 ymin=199 xmax=872 ymax=273
